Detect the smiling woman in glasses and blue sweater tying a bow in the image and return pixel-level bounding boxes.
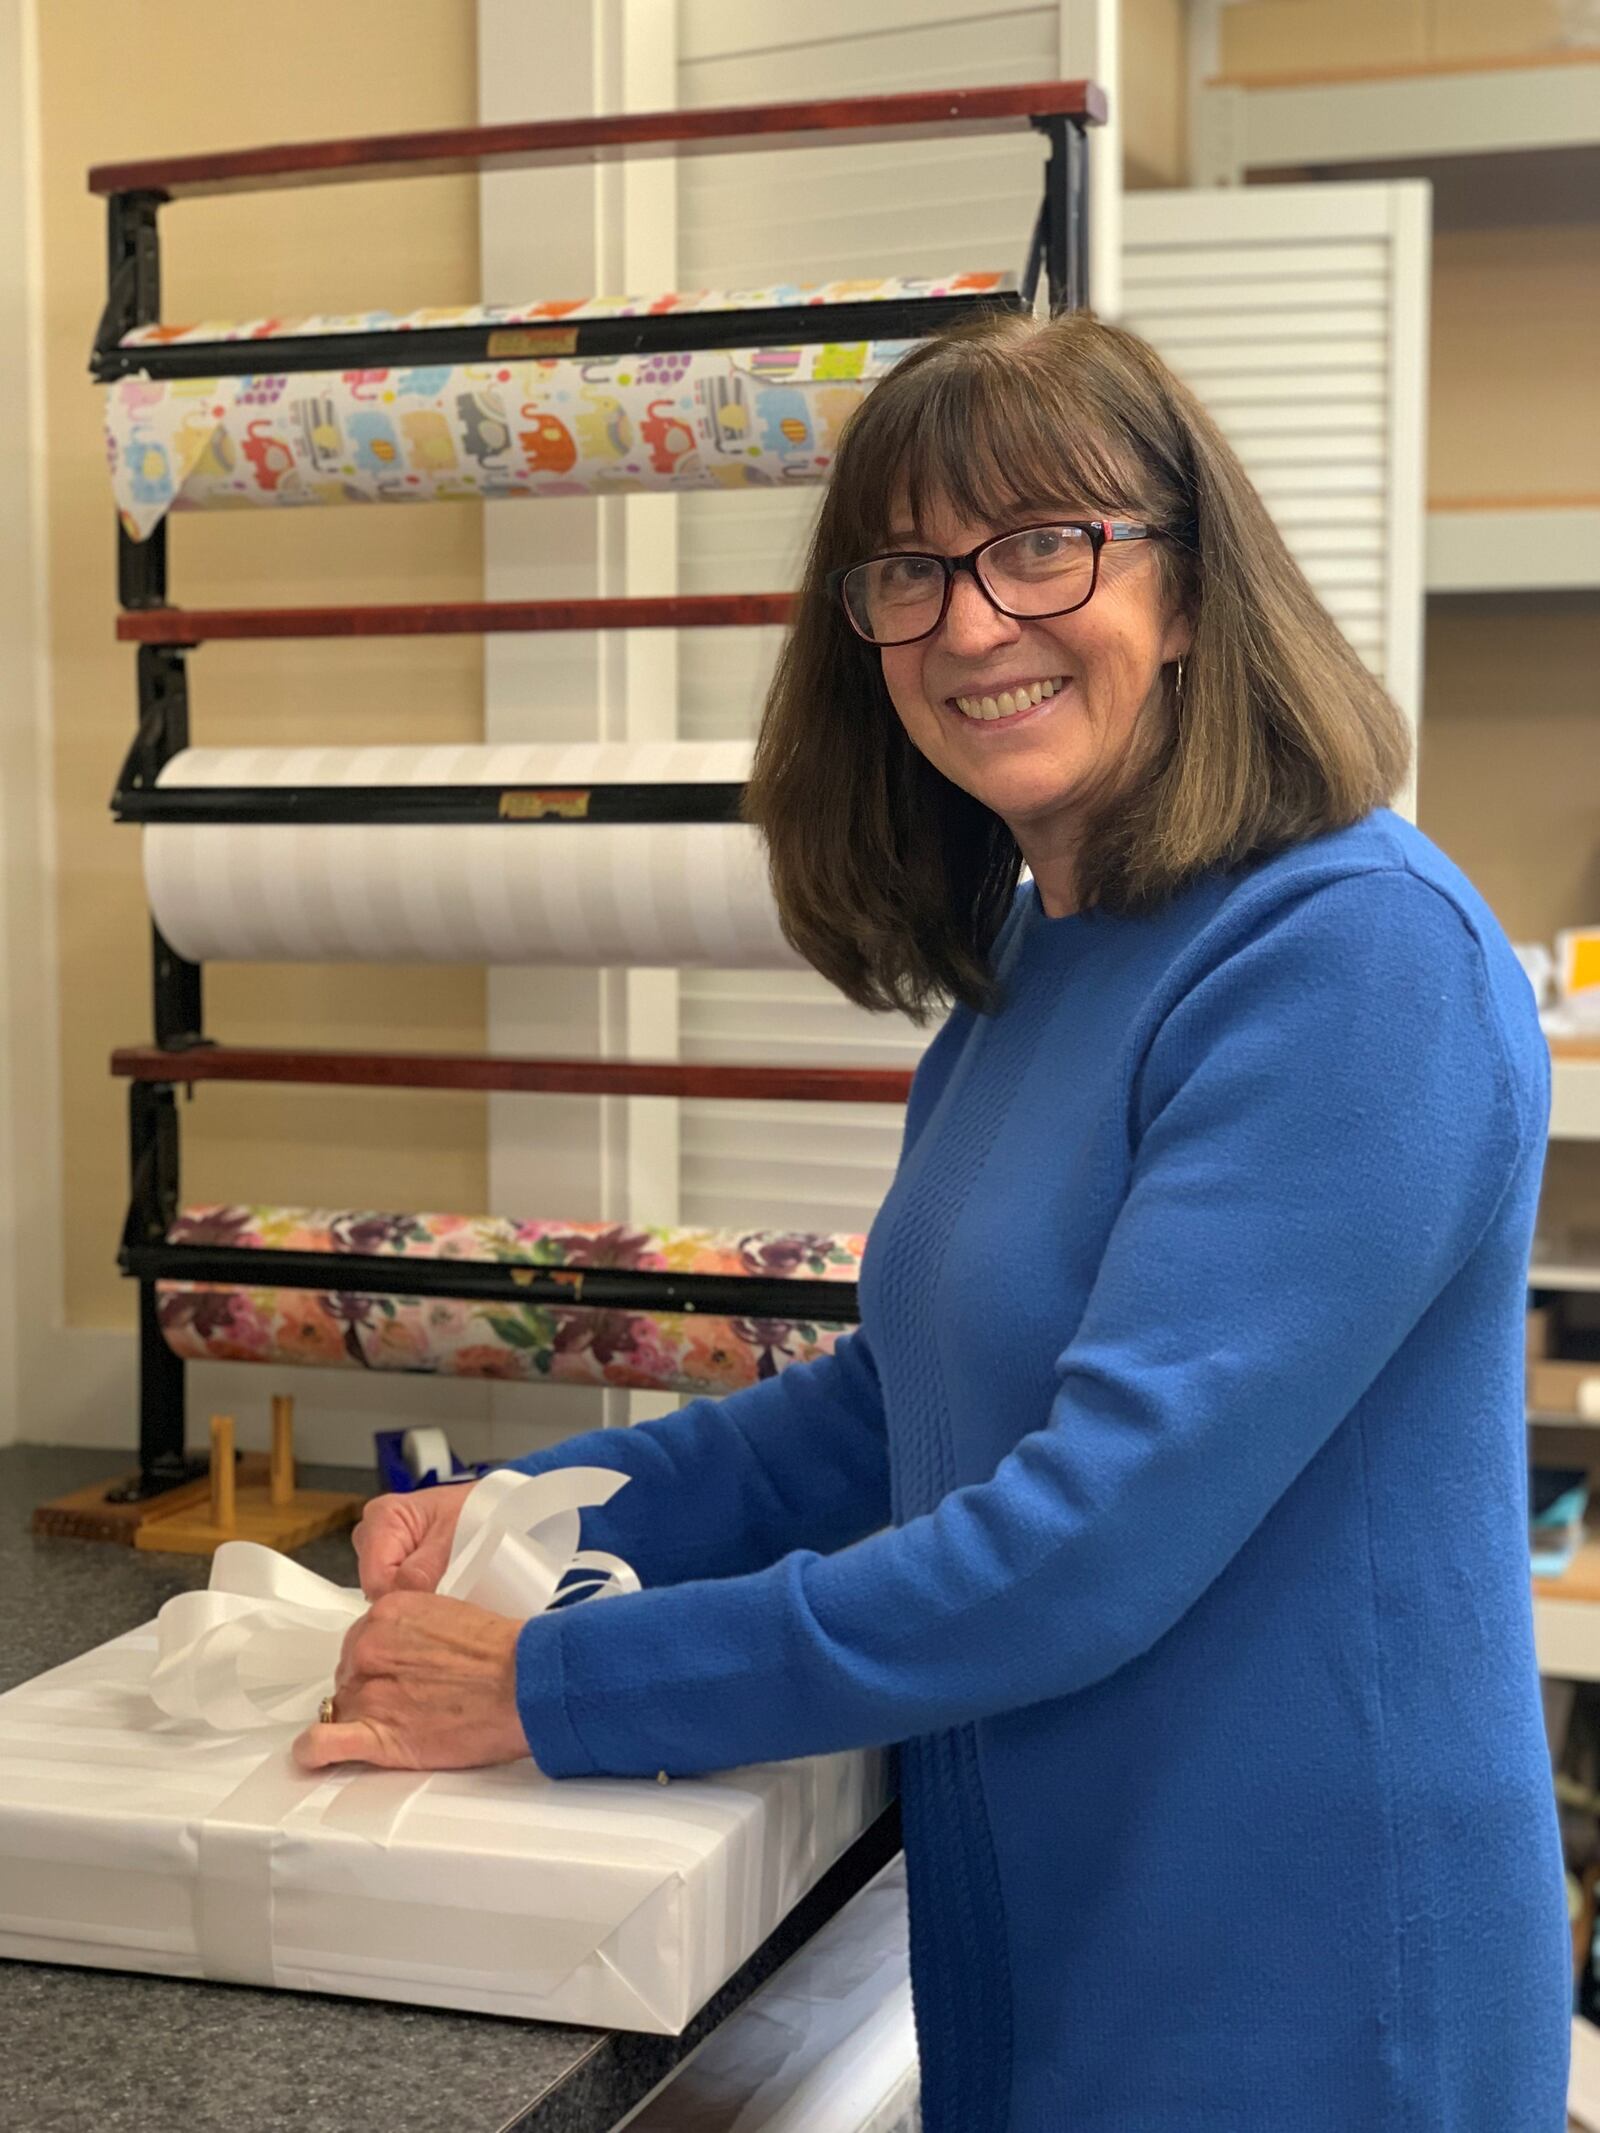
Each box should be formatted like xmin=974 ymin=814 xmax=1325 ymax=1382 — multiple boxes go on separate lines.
xmin=303 ymin=316 xmax=1568 ymax=2133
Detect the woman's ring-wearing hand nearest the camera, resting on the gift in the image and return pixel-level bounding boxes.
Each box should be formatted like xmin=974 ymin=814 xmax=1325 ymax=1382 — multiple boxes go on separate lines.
xmin=294 ymin=1591 xmax=527 ymax=1770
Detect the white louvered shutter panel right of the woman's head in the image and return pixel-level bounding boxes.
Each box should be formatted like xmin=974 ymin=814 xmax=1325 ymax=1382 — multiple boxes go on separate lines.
xmin=1122 ymin=181 xmax=1427 ymax=767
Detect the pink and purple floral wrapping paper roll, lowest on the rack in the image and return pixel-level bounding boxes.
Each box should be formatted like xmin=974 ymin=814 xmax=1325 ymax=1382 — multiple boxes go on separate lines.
xmin=156 ymin=1207 xmax=866 ymax=1395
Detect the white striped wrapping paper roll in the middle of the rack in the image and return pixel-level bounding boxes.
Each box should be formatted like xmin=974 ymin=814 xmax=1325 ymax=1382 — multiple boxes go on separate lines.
xmin=145 ymin=740 xmax=800 ymax=968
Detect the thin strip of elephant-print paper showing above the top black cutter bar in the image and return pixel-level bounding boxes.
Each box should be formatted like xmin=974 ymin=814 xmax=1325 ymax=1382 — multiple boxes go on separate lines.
xmin=117 ymin=273 xmax=1018 ymax=348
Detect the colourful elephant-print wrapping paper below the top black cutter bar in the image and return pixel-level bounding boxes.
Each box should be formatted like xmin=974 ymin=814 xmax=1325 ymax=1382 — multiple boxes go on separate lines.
xmin=105 ymin=341 xmax=915 ymax=540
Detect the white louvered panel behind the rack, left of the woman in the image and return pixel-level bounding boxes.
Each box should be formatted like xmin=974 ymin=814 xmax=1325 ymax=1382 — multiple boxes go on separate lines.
xmin=678 ymin=0 xmax=1060 ymax=1231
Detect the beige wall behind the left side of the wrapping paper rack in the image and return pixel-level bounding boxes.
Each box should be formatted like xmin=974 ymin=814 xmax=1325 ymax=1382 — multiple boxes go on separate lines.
xmin=38 ymin=0 xmax=484 ymax=1325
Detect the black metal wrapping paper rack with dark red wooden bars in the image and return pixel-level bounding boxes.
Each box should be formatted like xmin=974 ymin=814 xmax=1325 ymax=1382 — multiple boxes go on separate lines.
xmin=90 ymin=81 xmax=1105 ymax=1495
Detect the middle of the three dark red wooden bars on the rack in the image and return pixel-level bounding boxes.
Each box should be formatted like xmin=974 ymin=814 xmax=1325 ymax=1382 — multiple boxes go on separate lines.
xmin=117 ymin=593 xmax=794 ymax=644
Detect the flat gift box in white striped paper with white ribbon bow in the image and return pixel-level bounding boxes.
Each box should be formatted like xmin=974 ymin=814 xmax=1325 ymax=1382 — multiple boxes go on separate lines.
xmin=0 ymin=1470 xmax=885 ymax=2035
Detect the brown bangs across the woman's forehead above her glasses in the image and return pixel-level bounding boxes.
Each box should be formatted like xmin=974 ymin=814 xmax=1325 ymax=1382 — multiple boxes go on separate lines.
xmin=830 ymin=320 xmax=1137 ymax=563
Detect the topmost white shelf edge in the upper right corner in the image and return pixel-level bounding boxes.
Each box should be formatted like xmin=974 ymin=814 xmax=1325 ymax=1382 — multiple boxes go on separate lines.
xmin=1195 ymin=51 xmax=1600 ymax=186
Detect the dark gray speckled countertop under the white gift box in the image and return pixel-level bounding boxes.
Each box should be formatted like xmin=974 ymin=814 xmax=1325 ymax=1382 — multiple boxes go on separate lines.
xmin=0 ymin=1446 xmax=896 ymax=2133
